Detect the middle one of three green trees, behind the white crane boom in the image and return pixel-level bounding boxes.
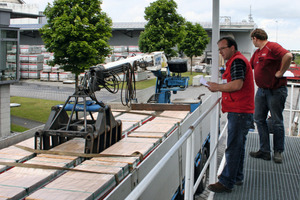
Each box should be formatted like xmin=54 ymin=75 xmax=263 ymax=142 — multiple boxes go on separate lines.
xmin=139 ymin=0 xmax=185 ymax=58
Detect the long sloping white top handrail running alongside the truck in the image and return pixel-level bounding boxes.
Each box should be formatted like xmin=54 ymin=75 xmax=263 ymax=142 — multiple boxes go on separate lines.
xmin=125 ymin=98 xmax=221 ymax=200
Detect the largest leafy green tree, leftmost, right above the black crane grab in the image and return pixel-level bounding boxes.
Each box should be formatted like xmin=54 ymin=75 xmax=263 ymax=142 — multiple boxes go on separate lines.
xmin=40 ymin=0 xmax=112 ymax=89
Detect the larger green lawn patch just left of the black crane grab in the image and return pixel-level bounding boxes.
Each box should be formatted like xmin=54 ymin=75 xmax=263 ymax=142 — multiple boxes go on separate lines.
xmin=10 ymin=97 xmax=63 ymax=123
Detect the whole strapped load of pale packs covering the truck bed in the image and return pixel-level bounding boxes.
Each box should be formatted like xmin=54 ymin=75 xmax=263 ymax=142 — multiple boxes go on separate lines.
xmin=0 ymin=111 xmax=188 ymax=200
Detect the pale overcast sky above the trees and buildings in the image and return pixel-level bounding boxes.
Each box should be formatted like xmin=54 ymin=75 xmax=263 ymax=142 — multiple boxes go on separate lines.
xmin=24 ymin=0 xmax=300 ymax=50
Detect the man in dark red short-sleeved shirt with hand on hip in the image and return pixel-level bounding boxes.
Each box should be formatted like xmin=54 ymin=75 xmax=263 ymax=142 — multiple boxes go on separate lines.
xmin=250 ymin=29 xmax=293 ymax=163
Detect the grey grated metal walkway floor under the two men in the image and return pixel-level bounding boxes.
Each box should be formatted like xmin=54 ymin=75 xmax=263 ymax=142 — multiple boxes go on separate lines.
xmin=213 ymin=133 xmax=300 ymax=200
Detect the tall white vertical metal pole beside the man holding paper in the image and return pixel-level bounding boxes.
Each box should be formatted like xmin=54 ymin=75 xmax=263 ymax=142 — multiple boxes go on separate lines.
xmin=209 ymin=0 xmax=220 ymax=184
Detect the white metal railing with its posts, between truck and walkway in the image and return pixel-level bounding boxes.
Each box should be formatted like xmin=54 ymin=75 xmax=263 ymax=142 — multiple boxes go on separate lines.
xmin=126 ymin=98 xmax=221 ymax=200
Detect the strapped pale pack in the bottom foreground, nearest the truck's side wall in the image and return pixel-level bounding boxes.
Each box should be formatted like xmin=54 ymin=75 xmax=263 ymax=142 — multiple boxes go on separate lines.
xmin=26 ymin=159 xmax=129 ymax=200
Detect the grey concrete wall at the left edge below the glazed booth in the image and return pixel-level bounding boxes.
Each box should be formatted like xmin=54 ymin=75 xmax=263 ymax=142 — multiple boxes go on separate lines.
xmin=0 ymin=84 xmax=10 ymax=138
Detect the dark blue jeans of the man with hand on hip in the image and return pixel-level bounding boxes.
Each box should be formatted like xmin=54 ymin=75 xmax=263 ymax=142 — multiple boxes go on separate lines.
xmin=254 ymin=86 xmax=287 ymax=152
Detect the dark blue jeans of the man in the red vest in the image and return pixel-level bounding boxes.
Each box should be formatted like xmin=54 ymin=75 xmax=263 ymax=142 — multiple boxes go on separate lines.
xmin=219 ymin=112 xmax=253 ymax=189
